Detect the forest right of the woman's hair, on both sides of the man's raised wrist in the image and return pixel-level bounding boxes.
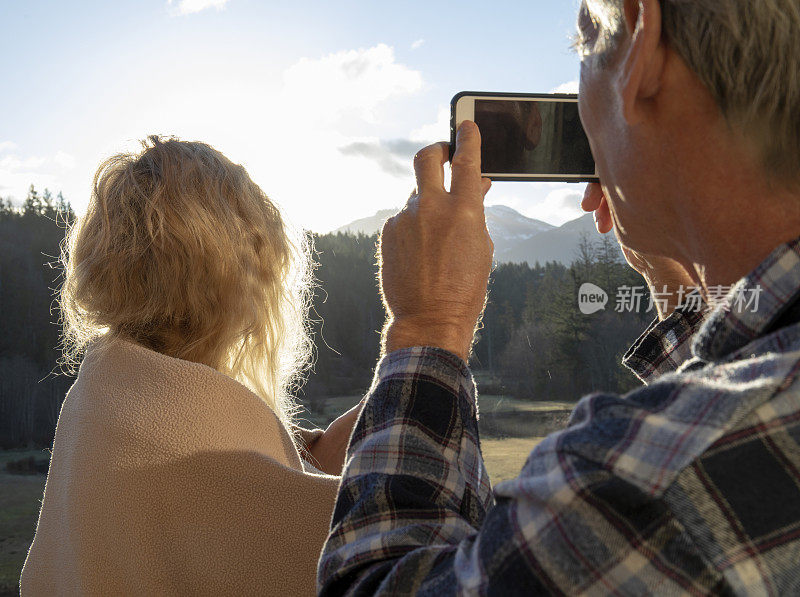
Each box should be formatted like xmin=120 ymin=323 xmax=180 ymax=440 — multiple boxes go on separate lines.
xmin=305 ymin=233 xmax=654 ymax=400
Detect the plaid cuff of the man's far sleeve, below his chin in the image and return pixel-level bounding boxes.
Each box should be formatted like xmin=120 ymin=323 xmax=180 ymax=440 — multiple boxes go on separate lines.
xmin=622 ymin=307 xmax=707 ymax=384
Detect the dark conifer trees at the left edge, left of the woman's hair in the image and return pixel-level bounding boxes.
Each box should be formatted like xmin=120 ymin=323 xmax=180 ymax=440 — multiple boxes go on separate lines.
xmin=0 ymin=186 xmax=75 ymax=448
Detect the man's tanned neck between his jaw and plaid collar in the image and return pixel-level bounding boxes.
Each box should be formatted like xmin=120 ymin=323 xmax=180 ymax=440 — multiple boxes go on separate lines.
xmin=668 ymin=113 xmax=800 ymax=308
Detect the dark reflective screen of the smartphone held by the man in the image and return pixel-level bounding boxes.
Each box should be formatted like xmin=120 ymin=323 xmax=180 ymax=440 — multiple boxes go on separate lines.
xmin=475 ymin=98 xmax=595 ymax=177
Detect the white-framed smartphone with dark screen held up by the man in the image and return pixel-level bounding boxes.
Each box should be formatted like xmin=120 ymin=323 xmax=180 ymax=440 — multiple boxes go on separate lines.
xmin=450 ymin=91 xmax=599 ymax=182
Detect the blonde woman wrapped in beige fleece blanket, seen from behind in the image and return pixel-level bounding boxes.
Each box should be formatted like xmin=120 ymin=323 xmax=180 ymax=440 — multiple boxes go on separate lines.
xmin=21 ymin=136 xmax=358 ymax=595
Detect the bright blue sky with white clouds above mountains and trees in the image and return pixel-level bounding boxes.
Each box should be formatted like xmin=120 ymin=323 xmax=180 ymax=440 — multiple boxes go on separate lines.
xmin=0 ymin=0 xmax=583 ymax=232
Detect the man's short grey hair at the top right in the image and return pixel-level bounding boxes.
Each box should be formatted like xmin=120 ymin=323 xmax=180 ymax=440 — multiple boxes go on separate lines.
xmin=576 ymin=0 xmax=800 ymax=185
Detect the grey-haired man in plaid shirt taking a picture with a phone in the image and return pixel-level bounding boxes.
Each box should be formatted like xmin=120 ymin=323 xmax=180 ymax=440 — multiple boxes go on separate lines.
xmin=318 ymin=0 xmax=800 ymax=596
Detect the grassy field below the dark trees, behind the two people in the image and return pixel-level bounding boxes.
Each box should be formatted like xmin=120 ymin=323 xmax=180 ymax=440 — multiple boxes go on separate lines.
xmin=0 ymin=396 xmax=572 ymax=597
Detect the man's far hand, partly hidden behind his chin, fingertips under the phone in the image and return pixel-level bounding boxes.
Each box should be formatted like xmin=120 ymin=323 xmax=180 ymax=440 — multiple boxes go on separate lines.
xmin=581 ymin=183 xmax=694 ymax=320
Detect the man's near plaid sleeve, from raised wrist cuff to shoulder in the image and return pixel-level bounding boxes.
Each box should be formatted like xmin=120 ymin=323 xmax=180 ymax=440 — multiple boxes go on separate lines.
xmin=317 ymin=347 xmax=713 ymax=597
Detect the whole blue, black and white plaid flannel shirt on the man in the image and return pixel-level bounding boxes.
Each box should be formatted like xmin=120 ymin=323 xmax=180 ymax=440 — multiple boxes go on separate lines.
xmin=318 ymin=235 xmax=800 ymax=597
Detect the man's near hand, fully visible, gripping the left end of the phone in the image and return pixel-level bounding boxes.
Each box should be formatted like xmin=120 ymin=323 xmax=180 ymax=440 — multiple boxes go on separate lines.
xmin=378 ymin=122 xmax=493 ymax=361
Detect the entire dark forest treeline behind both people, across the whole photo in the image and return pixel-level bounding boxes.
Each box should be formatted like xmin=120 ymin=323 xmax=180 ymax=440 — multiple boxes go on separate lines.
xmin=0 ymin=186 xmax=652 ymax=448
